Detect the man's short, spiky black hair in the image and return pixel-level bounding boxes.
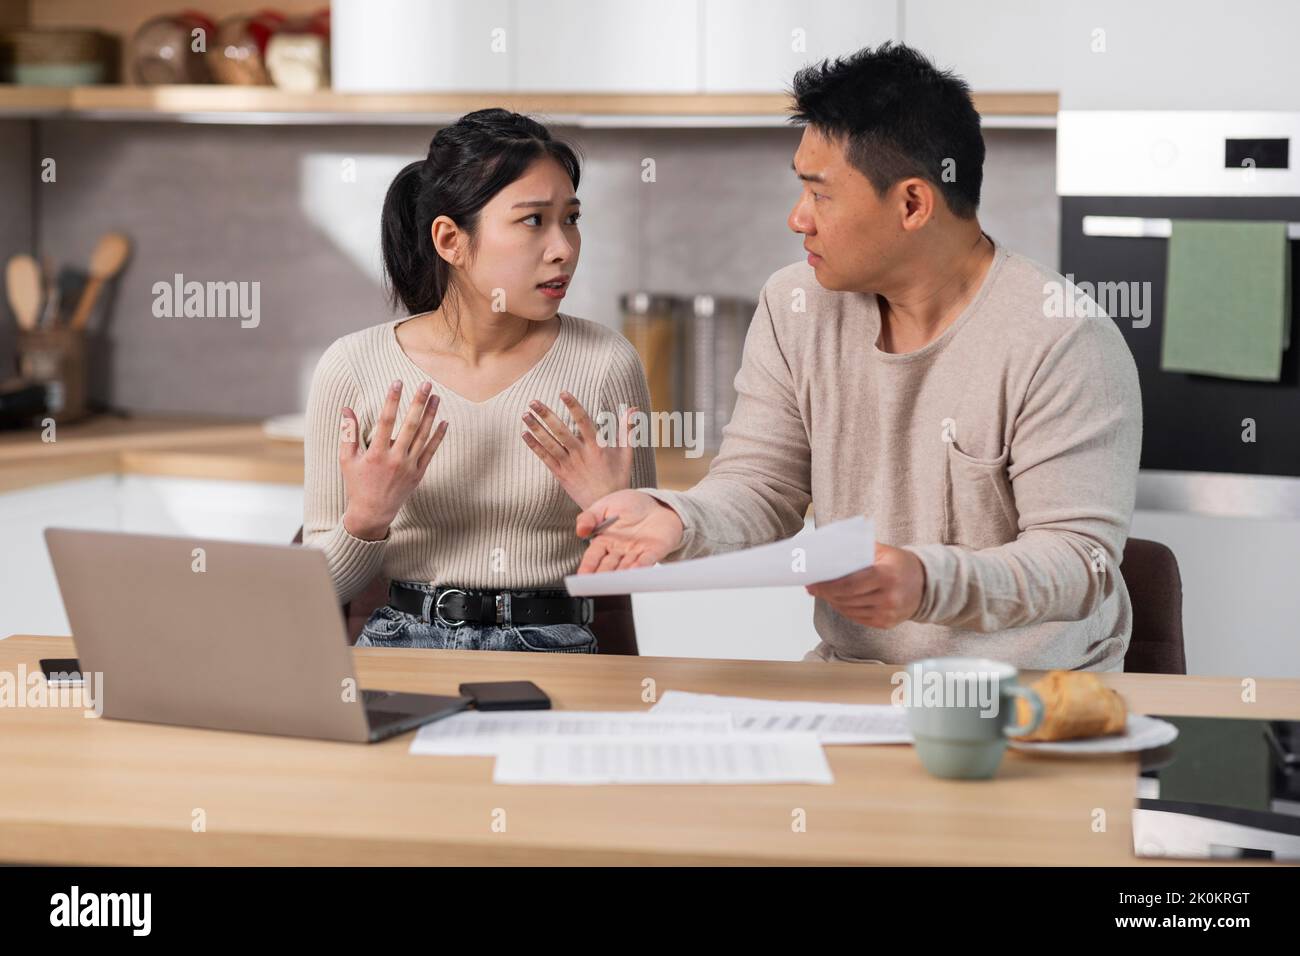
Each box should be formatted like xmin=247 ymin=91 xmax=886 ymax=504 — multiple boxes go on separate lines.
xmin=790 ymin=43 xmax=984 ymax=219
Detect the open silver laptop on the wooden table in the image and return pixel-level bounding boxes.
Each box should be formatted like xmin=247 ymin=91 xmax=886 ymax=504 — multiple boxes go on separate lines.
xmin=46 ymin=528 xmax=471 ymax=743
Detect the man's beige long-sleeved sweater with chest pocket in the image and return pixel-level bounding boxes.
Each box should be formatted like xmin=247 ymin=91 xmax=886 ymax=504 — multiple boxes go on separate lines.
xmin=642 ymin=243 xmax=1141 ymax=670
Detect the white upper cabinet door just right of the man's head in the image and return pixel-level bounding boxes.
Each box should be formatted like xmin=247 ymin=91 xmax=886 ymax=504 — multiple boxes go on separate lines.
xmin=902 ymin=0 xmax=1069 ymax=92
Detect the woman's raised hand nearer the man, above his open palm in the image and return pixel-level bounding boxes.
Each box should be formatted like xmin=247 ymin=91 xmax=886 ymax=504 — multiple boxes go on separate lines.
xmin=523 ymin=392 xmax=636 ymax=509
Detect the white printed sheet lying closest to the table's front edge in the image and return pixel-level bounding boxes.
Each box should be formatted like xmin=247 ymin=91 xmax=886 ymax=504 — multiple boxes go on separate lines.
xmin=493 ymin=734 xmax=835 ymax=784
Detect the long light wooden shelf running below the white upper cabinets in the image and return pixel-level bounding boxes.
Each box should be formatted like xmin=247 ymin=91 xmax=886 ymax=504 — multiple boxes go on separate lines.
xmin=0 ymin=85 xmax=1058 ymax=126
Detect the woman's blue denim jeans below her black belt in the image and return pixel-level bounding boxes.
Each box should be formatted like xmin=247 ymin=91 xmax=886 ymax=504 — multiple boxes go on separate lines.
xmin=356 ymin=591 xmax=595 ymax=654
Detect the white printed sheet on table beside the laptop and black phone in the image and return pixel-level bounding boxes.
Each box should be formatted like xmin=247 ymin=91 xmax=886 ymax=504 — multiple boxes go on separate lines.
xmin=411 ymin=710 xmax=731 ymax=757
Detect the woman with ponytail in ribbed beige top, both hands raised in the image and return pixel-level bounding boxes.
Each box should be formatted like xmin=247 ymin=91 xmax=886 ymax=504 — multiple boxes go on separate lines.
xmin=303 ymin=109 xmax=655 ymax=653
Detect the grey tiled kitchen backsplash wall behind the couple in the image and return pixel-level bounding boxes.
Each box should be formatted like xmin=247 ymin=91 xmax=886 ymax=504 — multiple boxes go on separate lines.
xmin=0 ymin=121 xmax=1058 ymax=416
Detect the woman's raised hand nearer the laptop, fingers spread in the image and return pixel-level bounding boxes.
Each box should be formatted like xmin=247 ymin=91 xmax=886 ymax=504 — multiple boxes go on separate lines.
xmin=338 ymin=381 xmax=447 ymax=541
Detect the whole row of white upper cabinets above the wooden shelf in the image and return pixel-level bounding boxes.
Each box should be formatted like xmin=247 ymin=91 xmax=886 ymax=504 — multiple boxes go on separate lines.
xmin=322 ymin=0 xmax=1061 ymax=106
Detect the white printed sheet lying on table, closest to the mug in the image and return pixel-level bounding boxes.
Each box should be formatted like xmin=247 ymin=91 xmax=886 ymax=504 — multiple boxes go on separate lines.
xmin=650 ymin=691 xmax=911 ymax=744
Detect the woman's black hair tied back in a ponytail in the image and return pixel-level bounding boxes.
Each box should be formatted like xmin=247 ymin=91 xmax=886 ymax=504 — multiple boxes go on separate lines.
xmin=380 ymin=109 xmax=580 ymax=315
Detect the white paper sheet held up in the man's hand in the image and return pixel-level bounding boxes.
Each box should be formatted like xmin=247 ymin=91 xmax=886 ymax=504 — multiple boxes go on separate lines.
xmin=564 ymin=515 xmax=876 ymax=597
